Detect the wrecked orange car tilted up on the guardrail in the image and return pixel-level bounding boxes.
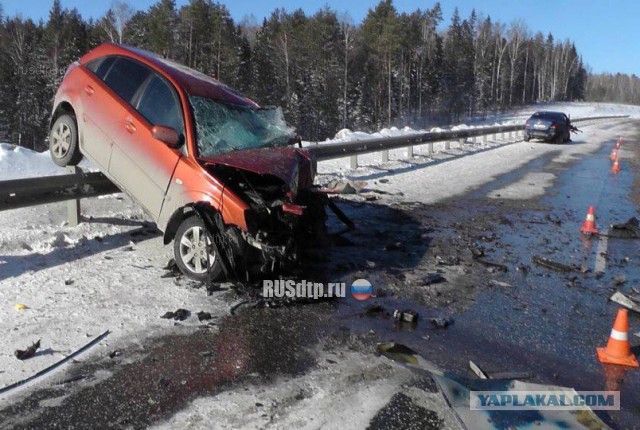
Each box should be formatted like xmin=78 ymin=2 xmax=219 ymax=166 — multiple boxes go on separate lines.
xmin=49 ymin=43 xmax=327 ymax=281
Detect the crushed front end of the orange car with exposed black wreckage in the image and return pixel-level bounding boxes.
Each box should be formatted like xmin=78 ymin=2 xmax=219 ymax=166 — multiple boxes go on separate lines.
xmin=205 ymin=148 xmax=348 ymax=277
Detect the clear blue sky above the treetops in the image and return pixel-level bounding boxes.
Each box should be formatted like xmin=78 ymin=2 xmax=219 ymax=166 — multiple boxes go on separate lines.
xmin=0 ymin=0 xmax=640 ymax=75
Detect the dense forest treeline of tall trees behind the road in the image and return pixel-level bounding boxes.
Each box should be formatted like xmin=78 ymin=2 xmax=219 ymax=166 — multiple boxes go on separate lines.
xmin=0 ymin=0 xmax=638 ymax=148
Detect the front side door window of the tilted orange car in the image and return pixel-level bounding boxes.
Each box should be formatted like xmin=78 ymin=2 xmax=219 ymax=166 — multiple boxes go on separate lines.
xmin=138 ymin=76 xmax=184 ymax=134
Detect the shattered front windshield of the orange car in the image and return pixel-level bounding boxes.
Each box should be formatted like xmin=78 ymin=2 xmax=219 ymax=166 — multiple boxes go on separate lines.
xmin=189 ymin=96 xmax=295 ymax=157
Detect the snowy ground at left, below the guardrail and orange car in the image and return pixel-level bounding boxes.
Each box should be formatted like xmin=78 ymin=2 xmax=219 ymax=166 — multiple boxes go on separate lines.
xmin=0 ymin=196 xmax=229 ymax=387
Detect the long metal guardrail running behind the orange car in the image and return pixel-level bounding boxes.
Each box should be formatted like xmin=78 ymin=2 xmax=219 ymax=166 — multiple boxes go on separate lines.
xmin=0 ymin=115 xmax=629 ymax=225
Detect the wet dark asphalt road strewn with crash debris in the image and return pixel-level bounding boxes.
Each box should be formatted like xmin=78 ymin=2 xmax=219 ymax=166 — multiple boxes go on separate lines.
xmin=0 ymin=122 xmax=640 ymax=429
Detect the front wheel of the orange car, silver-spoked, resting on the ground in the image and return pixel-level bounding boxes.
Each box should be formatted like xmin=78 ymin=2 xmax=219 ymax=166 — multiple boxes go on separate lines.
xmin=173 ymin=215 xmax=222 ymax=282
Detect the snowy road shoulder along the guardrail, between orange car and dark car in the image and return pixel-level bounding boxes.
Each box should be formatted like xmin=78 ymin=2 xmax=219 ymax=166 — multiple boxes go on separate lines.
xmin=318 ymin=124 xmax=631 ymax=204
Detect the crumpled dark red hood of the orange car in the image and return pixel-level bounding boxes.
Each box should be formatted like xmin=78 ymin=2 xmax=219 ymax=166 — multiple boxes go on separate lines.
xmin=201 ymin=147 xmax=315 ymax=190
